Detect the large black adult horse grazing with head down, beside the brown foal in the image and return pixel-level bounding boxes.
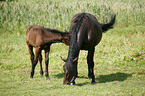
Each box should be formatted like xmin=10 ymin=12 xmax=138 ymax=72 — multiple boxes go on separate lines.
xmin=61 ymin=13 xmax=116 ymax=84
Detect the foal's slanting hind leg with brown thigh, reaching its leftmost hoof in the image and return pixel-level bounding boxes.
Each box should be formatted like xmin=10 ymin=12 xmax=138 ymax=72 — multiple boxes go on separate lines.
xmin=30 ymin=47 xmax=41 ymax=78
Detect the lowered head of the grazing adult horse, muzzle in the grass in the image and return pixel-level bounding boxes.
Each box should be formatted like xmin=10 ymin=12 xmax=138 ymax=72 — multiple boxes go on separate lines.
xmin=61 ymin=57 xmax=78 ymax=84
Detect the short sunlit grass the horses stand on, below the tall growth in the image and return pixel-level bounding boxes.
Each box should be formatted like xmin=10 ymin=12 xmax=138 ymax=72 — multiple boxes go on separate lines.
xmin=0 ymin=26 xmax=145 ymax=96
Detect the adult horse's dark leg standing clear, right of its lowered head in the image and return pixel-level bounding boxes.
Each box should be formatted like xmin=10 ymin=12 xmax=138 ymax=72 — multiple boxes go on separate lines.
xmin=87 ymin=48 xmax=95 ymax=83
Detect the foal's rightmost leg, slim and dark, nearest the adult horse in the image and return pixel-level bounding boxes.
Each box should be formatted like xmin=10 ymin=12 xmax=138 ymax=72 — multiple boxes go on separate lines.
xmin=45 ymin=47 xmax=50 ymax=79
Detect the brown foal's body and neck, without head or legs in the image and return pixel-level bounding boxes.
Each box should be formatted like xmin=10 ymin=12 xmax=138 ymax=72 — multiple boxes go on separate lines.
xmin=26 ymin=25 xmax=61 ymax=47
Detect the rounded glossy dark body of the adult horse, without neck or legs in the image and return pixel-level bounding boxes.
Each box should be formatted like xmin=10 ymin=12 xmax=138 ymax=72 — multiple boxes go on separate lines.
xmin=70 ymin=13 xmax=102 ymax=50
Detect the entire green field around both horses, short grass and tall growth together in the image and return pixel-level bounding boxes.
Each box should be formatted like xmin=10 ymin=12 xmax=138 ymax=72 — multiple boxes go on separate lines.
xmin=0 ymin=0 xmax=145 ymax=96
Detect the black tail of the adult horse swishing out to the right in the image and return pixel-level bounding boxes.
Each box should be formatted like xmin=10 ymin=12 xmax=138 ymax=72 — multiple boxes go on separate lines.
xmin=101 ymin=15 xmax=116 ymax=33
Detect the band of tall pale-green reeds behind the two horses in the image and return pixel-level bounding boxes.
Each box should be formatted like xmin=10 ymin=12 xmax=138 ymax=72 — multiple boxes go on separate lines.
xmin=0 ymin=0 xmax=145 ymax=34
